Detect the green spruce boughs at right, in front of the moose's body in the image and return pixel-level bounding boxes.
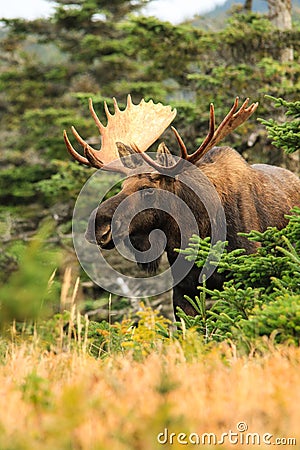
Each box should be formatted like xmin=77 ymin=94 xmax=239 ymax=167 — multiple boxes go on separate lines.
xmin=179 ymin=208 xmax=300 ymax=349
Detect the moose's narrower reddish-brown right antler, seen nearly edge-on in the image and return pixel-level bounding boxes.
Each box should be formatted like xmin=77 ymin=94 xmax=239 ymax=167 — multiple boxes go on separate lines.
xmin=171 ymin=97 xmax=258 ymax=164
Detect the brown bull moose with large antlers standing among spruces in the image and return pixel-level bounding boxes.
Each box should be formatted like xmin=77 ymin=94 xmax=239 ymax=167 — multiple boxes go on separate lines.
xmin=64 ymin=95 xmax=300 ymax=315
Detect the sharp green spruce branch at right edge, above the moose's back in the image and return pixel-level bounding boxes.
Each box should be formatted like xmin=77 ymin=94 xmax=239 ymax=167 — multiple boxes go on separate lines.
xmin=259 ymin=95 xmax=300 ymax=153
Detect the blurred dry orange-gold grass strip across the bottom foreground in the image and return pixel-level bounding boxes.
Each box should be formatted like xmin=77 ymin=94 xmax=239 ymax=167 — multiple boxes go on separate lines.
xmin=0 ymin=334 xmax=300 ymax=450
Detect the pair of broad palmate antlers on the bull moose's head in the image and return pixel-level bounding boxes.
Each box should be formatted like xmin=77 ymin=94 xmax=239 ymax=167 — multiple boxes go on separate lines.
xmin=64 ymin=95 xmax=258 ymax=174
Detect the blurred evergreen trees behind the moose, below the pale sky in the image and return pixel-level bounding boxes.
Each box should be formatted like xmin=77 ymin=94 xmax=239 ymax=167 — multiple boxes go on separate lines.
xmin=0 ymin=0 xmax=300 ymax=310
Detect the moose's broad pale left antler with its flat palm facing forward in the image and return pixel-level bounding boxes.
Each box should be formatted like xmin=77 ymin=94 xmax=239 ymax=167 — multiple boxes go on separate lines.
xmin=64 ymin=95 xmax=177 ymax=170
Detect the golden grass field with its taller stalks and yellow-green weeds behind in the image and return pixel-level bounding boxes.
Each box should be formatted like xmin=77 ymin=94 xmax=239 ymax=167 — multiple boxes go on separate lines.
xmin=0 ymin=271 xmax=300 ymax=450
